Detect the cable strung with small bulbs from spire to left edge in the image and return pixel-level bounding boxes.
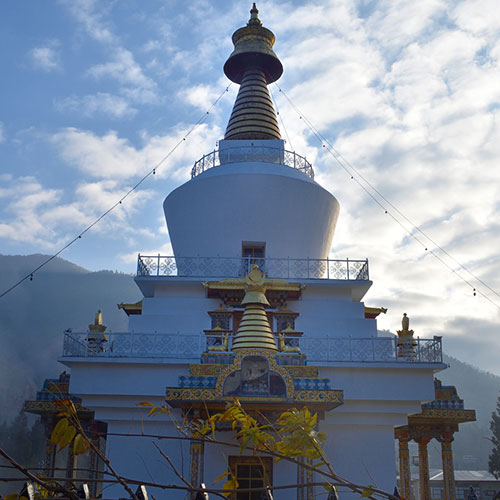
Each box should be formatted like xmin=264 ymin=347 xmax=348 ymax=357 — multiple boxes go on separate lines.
xmin=0 ymin=83 xmax=232 ymax=299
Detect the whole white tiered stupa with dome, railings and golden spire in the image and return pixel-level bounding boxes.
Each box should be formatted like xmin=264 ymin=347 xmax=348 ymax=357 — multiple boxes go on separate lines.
xmin=61 ymin=5 xmax=450 ymax=500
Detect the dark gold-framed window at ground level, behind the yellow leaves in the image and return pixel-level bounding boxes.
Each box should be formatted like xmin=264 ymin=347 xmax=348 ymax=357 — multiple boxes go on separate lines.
xmin=229 ymin=456 xmax=273 ymax=500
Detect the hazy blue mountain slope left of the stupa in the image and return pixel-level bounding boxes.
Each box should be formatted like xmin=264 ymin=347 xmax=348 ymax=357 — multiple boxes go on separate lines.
xmin=0 ymin=255 xmax=140 ymax=423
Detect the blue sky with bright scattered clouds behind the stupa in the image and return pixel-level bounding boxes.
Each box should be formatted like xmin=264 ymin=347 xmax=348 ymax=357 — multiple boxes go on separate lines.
xmin=0 ymin=0 xmax=500 ymax=375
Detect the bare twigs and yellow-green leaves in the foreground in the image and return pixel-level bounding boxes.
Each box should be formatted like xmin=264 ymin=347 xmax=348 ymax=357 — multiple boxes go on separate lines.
xmin=0 ymin=399 xmax=397 ymax=500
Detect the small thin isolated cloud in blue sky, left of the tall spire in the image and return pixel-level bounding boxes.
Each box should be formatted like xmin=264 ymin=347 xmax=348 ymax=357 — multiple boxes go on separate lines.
xmin=55 ymin=92 xmax=137 ymax=119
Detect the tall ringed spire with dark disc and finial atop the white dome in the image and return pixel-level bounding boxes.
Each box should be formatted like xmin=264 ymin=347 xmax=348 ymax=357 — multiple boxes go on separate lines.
xmin=224 ymin=4 xmax=283 ymax=140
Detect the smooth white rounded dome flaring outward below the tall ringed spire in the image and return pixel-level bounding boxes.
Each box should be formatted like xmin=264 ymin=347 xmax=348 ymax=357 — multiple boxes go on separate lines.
xmin=164 ymin=162 xmax=339 ymax=259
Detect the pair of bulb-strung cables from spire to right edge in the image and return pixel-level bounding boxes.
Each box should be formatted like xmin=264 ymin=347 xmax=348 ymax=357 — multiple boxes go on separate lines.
xmin=275 ymin=83 xmax=500 ymax=309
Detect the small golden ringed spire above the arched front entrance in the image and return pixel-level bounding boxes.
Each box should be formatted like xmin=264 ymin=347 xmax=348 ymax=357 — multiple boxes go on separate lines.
xmin=231 ymin=266 xmax=278 ymax=351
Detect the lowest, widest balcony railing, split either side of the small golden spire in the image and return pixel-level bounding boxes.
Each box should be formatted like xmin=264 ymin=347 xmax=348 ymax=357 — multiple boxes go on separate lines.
xmin=63 ymin=332 xmax=443 ymax=364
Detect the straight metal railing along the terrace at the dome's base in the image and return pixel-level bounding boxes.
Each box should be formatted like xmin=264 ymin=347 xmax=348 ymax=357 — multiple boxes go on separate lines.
xmin=137 ymin=255 xmax=370 ymax=281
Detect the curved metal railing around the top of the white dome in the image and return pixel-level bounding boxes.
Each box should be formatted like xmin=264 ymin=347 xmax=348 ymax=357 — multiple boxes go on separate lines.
xmin=191 ymin=146 xmax=314 ymax=179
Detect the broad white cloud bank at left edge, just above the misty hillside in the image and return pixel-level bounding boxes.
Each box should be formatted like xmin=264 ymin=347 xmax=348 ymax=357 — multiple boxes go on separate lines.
xmin=0 ymin=176 xmax=155 ymax=252
